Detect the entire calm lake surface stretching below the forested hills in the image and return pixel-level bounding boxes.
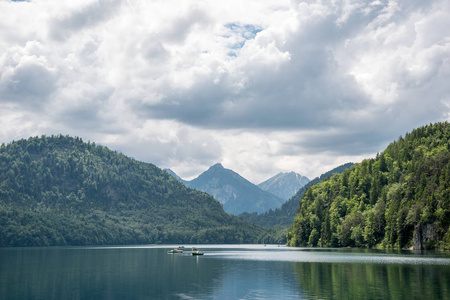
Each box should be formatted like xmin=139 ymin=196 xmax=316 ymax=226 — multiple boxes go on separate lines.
xmin=0 ymin=245 xmax=450 ymax=299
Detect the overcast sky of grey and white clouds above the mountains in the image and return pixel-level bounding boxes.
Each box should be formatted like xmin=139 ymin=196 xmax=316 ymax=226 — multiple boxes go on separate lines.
xmin=0 ymin=0 xmax=450 ymax=183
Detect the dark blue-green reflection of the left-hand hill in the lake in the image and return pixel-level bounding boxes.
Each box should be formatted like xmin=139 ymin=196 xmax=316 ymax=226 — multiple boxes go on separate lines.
xmin=0 ymin=248 xmax=223 ymax=299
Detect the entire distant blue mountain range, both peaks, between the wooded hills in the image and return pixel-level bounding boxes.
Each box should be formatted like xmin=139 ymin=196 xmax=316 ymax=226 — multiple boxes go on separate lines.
xmin=166 ymin=164 xmax=309 ymax=215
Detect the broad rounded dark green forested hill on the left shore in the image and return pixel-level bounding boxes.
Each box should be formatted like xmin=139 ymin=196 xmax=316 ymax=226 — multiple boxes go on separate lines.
xmin=0 ymin=136 xmax=261 ymax=246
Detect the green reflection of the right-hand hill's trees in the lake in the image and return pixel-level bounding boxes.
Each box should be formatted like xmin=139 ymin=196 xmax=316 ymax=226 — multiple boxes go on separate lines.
xmin=295 ymin=263 xmax=450 ymax=300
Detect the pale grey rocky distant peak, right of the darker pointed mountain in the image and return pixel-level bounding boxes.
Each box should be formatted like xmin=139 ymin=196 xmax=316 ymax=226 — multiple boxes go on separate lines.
xmin=258 ymin=172 xmax=310 ymax=201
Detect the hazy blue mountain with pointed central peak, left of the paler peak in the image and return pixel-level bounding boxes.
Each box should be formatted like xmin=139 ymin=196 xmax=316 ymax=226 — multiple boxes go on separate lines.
xmin=165 ymin=164 xmax=296 ymax=215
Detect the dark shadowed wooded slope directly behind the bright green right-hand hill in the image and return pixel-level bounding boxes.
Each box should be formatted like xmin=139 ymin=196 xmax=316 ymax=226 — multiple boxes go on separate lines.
xmin=239 ymin=163 xmax=353 ymax=244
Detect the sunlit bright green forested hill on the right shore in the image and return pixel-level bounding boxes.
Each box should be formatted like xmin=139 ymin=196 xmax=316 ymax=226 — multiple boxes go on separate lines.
xmin=288 ymin=122 xmax=450 ymax=249
